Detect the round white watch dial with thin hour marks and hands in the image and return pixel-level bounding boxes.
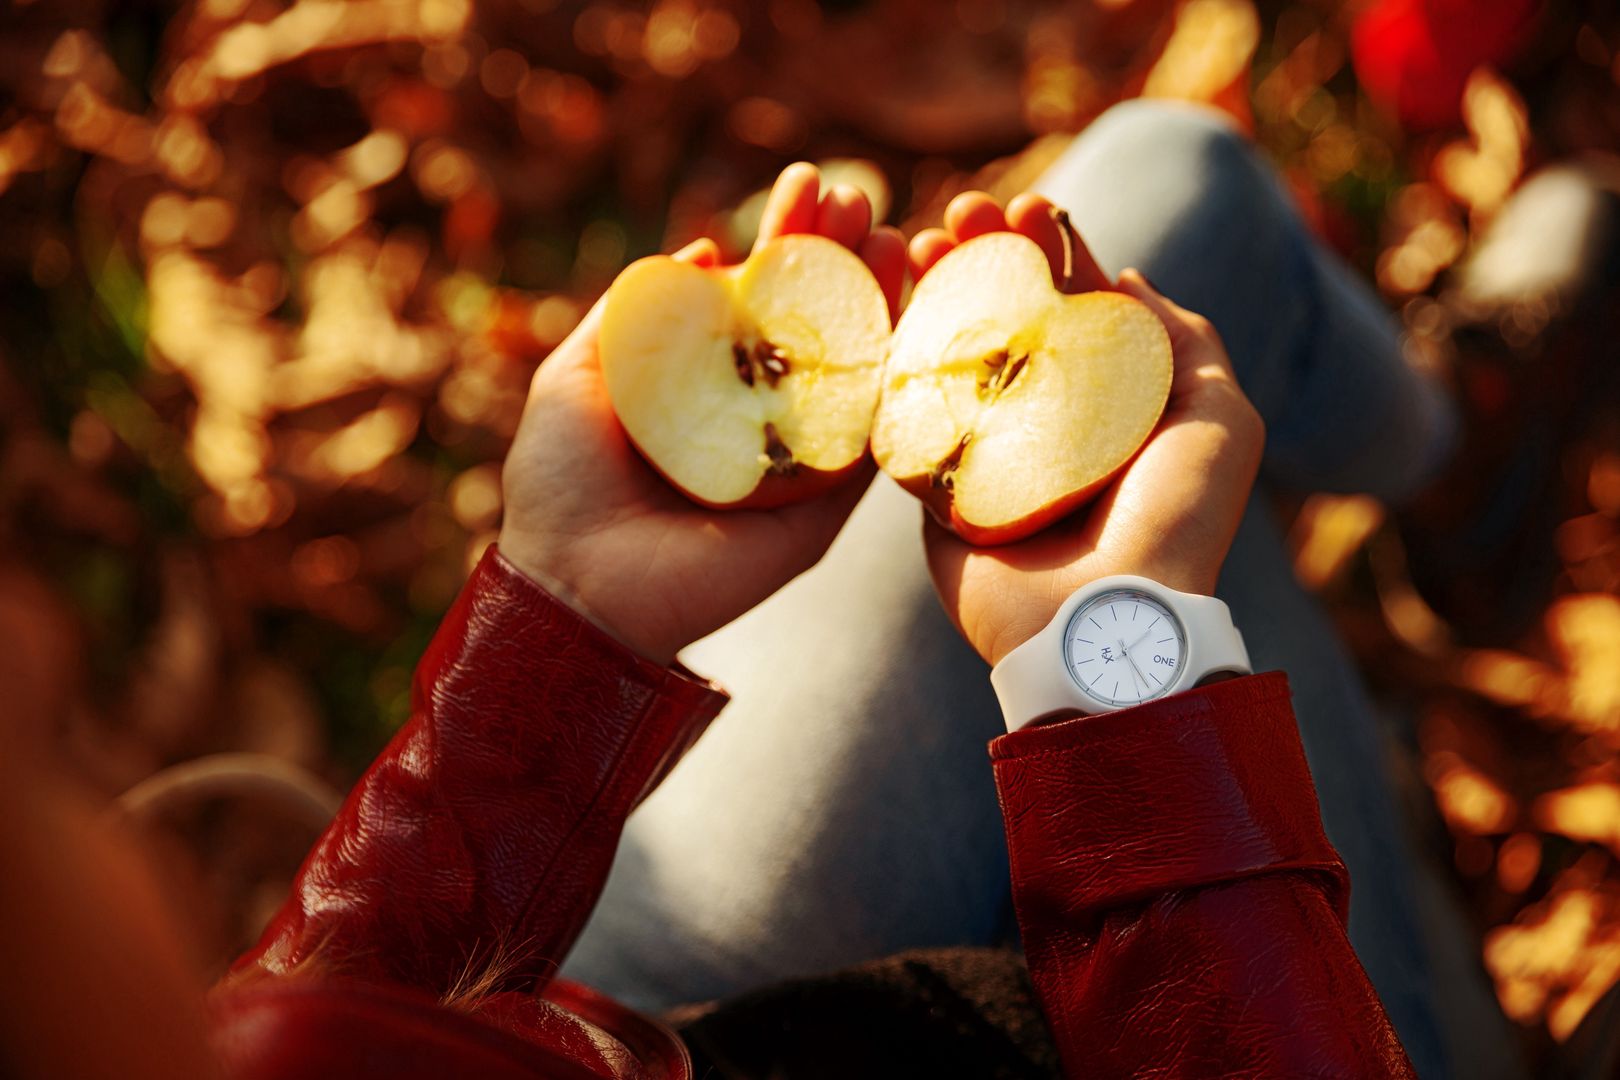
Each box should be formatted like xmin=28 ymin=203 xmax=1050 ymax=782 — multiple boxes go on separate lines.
xmin=1063 ymin=589 xmax=1187 ymax=706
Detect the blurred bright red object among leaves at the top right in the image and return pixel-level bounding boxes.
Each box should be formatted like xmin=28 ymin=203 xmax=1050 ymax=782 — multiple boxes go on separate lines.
xmin=1351 ymin=0 xmax=1541 ymax=130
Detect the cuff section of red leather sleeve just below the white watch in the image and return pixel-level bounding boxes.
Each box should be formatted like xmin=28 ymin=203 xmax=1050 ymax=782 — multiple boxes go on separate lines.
xmin=990 ymin=672 xmax=1348 ymax=920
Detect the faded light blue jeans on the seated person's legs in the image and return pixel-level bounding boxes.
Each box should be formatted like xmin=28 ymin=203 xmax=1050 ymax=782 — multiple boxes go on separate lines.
xmin=564 ymin=102 xmax=1513 ymax=1077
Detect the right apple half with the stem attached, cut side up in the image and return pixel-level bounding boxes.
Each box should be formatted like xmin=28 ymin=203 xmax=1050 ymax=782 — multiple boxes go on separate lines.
xmin=872 ymin=232 xmax=1173 ymax=544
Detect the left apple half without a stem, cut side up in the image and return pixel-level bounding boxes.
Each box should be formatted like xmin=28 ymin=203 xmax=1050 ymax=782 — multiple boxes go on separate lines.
xmin=599 ymin=235 xmax=889 ymax=508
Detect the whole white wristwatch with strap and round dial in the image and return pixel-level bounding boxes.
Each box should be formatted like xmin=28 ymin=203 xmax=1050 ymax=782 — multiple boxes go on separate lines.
xmin=990 ymin=575 xmax=1252 ymax=732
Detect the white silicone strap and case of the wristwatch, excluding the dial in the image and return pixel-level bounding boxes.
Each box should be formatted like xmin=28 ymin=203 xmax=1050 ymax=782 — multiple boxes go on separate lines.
xmin=990 ymin=575 xmax=1252 ymax=732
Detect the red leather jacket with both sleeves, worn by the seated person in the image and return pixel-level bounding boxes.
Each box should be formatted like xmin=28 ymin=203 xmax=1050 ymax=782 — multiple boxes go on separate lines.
xmin=212 ymin=551 xmax=1411 ymax=1080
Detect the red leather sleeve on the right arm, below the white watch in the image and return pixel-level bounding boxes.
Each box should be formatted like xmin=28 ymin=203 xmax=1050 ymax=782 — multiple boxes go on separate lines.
xmin=991 ymin=674 xmax=1413 ymax=1077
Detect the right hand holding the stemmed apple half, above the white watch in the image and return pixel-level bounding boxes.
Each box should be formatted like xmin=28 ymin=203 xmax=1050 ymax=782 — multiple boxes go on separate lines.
xmin=910 ymin=191 xmax=1265 ymax=664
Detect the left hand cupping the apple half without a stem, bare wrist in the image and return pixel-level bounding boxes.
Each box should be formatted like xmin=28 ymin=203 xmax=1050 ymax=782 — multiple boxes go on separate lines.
xmin=501 ymin=164 xmax=906 ymax=664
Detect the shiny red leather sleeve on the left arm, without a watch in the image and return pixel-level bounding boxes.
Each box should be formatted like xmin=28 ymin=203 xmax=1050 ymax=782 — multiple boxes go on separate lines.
xmin=237 ymin=549 xmax=726 ymax=994
